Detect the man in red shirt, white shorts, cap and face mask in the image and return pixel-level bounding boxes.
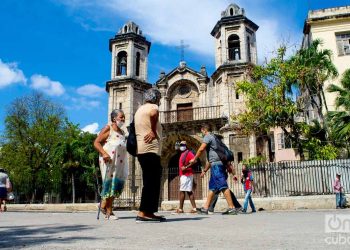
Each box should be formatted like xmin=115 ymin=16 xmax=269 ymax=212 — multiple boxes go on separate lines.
xmin=176 ymin=141 xmax=197 ymax=214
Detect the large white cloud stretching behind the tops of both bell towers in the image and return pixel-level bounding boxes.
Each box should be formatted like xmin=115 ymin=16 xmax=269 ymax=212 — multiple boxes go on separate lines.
xmin=56 ymin=0 xmax=300 ymax=62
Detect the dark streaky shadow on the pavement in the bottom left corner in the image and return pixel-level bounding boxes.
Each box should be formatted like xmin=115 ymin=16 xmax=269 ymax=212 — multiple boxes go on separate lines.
xmin=0 ymin=224 xmax=100 ymax=248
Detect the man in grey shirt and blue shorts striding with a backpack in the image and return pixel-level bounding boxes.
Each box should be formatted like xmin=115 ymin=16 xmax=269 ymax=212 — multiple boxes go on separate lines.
xmin=190 ymin=124 xmax=237 ymax=214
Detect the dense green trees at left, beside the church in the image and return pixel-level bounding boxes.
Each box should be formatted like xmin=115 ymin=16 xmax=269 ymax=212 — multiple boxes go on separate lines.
xmin=0 ymin=93 xmax=98 ymax=202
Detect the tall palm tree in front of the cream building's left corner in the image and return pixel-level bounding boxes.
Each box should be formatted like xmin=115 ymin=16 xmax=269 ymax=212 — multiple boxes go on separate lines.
xmin=292 ymin=39 xmax=338 ymax=126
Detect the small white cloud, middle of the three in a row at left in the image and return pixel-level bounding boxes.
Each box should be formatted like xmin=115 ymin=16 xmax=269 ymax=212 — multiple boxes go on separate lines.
xmin=30 ymin=74 xmax=65 ymax=96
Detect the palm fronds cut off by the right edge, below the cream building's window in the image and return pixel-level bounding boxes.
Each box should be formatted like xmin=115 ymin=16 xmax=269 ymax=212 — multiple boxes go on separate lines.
xmin=327 ymin=69 xmax=350 ymax=148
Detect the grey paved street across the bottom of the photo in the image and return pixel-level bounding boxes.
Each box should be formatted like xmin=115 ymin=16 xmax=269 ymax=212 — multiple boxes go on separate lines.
xmin=0 ymin=210 xmax=350 ymax=249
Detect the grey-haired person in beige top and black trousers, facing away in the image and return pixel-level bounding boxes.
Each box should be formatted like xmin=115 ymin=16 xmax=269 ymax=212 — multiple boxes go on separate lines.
xmin=134 ymin=88 xmax=166 ymax=222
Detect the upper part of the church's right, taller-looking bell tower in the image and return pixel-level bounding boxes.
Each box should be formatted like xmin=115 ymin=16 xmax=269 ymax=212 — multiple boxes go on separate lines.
xmin=211 ymin=4 xmax=259 ymax=117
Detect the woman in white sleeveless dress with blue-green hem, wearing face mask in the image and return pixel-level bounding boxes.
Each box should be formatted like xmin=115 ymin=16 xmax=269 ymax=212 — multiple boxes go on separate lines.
xmin=94 ymin=109 xmax=128 ymax=220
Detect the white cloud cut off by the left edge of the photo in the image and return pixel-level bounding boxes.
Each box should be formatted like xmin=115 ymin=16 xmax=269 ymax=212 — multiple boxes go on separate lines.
xmin=0 ymin=59 xmax=27 ymax=89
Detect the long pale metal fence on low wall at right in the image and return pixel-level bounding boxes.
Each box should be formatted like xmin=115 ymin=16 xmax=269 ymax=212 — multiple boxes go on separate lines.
xmin=247 ymin=159 xmax=350 ymax=197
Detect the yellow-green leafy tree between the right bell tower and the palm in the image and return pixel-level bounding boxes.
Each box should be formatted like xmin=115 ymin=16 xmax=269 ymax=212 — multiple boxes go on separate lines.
xmin=233 ymin=47 xmax=304 ymax=158
